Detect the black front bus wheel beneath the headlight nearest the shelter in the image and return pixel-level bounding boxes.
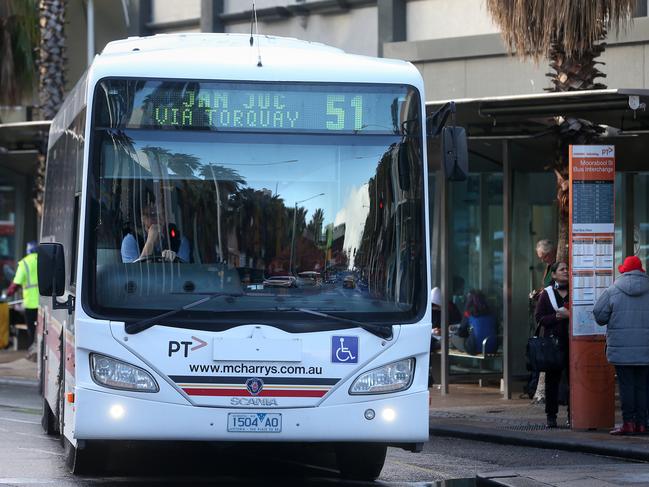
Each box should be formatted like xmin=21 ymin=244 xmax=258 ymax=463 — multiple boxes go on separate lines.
xmin=336 ymin=443 xmax=388 ymax=480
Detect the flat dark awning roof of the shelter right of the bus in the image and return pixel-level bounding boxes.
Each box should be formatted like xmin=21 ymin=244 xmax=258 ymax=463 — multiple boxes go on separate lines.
xmin=426 ymin=88 xmax=649 ymax=171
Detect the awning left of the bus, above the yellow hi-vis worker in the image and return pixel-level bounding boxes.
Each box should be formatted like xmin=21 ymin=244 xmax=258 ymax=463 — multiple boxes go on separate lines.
xmin=0 ymin=120 xmax=50 ymax=176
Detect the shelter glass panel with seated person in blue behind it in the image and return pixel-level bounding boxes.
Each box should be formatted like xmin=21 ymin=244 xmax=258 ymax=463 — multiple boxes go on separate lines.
xmin=449 ymin=171 xmax=503 ymax=375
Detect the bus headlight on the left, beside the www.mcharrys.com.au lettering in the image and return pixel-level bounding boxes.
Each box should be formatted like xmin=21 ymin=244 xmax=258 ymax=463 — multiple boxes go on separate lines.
xmin=90 ymin=353 xmax=160 ymax=392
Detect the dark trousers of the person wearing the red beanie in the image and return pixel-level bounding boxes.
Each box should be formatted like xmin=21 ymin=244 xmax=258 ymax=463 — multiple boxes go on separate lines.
xmin=615 ymin=365 xmax=649 ymax=424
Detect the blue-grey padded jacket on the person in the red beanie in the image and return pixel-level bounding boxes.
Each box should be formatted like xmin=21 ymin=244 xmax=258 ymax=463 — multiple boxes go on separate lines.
xmin=593 ymin=271 xmax=649 ymax=365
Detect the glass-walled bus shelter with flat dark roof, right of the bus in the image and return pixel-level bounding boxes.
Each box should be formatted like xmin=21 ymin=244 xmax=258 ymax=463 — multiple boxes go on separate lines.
xmin=426 ymin=89 xmax=649 ymax=399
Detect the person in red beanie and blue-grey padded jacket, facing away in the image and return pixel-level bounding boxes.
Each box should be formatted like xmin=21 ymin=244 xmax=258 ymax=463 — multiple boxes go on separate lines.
xmin=593 ymin=255 xmax=649 ymax=435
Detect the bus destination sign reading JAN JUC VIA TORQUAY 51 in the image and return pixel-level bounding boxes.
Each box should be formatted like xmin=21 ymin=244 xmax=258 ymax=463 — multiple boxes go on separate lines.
xmin=118 ymin=81 xmax=412 ymax=134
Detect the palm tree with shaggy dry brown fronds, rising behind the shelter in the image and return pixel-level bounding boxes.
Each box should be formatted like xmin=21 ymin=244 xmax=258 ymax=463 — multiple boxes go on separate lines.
xmin=487 ymin=0 xmax=637 ymax=262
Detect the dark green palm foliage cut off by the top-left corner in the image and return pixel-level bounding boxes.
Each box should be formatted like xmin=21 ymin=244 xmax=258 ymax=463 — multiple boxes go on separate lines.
xmin=0 ymin=0 xmax=38 ymax=105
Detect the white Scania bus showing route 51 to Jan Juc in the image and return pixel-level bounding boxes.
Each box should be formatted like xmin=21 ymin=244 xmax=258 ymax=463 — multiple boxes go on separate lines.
xmin=34 ymin=34 xmax=431 ymax=479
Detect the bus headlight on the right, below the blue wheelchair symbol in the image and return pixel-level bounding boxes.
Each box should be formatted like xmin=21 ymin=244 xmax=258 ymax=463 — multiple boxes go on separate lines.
xmin=349 ymin=358 xmax=415 ymax=394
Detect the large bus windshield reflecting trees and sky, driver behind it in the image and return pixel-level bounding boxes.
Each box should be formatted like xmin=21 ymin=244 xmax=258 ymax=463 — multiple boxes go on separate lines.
xmin=84 ymin=79 xmax=427 ymax=325
